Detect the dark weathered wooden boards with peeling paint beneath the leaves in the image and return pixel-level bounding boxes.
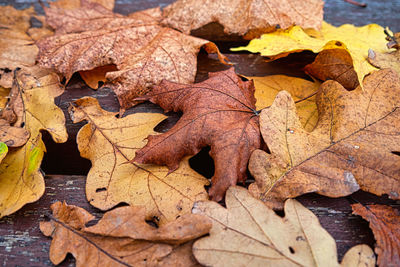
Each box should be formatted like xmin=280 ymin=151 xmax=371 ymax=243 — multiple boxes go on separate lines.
xmin=0 ymin=0 xmax=400 ymax=266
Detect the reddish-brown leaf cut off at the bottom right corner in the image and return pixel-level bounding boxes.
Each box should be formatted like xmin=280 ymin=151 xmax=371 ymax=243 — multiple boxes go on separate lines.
xmin=351 ymin=204 xmax=400 ymax=267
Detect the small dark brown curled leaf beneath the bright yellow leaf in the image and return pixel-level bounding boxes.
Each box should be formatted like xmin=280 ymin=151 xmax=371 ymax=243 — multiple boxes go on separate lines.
xmin=304 ymin=41 xmax=360 ymax=90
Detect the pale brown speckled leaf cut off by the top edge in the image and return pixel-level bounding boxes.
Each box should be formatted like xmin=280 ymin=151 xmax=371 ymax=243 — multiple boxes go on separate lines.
xmin=163 ymin=0 xmax=324 ymax=38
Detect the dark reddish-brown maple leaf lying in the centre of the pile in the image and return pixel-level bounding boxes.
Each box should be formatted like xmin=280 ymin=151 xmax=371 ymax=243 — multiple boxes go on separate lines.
xmin=134 ymin=68 xmax=260 ymax=201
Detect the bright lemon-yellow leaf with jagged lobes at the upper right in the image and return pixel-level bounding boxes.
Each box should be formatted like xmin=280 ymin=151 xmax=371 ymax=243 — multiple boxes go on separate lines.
xmin=232 ymin=22 xmax=388 ymax=88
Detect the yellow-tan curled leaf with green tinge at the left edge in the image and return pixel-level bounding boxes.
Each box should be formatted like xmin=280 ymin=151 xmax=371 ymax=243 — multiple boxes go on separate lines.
xmin=0 ymin=70 xmax=67 ymax=217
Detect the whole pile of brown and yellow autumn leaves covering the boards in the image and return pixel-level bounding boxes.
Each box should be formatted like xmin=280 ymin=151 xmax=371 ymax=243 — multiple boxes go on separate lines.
xmin=0 ymin=0 xmax=400 ymax=266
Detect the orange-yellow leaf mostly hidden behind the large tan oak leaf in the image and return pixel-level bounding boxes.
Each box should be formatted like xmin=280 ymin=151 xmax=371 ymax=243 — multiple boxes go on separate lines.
xmin=252 ymin=75 xmax=320 ymax=131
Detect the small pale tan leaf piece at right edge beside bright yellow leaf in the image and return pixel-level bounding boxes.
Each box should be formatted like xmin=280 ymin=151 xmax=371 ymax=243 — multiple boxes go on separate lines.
xmin=368 ymin=32 xmax=400 ymax=75
